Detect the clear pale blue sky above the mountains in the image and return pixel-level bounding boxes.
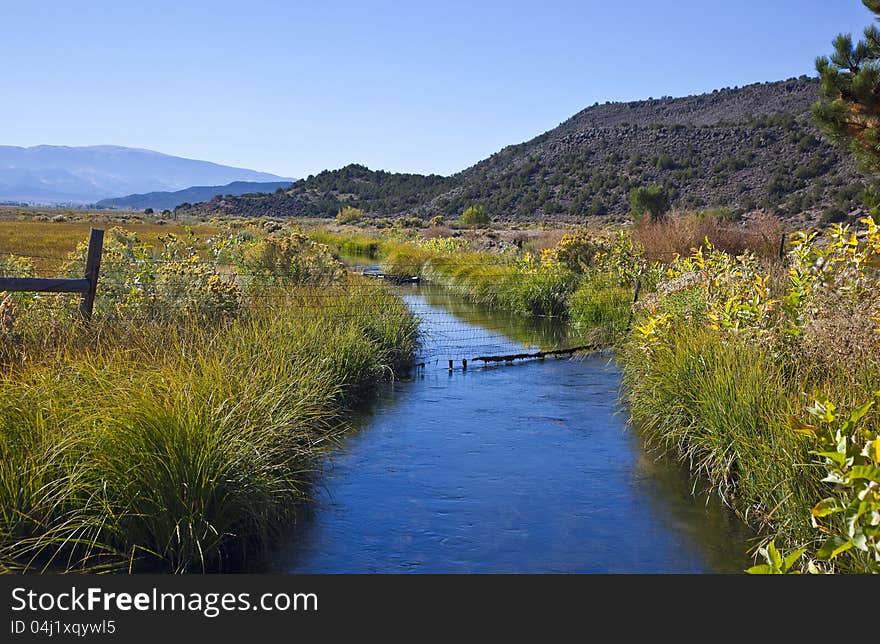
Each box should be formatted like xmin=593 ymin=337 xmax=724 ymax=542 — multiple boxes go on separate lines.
xmin=0 ymin=0 xmax=872 ymax=177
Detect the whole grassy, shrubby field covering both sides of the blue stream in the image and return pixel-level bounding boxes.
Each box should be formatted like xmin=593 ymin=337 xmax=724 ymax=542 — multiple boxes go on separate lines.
xmin=0 ymin=212 xmax=880 ymax=572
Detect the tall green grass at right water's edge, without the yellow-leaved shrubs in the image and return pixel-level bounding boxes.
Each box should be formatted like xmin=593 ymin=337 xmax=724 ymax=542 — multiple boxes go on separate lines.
xmin=621 ymin=328 xmax=821 ymax=542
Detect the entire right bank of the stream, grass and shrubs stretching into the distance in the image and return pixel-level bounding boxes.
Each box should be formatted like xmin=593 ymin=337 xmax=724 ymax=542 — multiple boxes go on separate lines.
xmin=360 ymin=217 xmax=880 ymax=572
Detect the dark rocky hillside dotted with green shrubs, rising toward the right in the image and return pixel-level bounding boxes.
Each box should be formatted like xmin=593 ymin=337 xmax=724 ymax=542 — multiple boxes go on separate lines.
xmin=177 ymin=76 xmax=863 ymax=221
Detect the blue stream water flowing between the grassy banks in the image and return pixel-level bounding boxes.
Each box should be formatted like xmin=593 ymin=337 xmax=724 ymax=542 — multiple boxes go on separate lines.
xmin=273 ymin=294 xmax=748 ymax=573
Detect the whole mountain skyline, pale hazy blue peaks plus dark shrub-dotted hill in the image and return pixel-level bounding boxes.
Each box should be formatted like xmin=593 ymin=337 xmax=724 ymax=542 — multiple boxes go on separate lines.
xmin=6 ymin=76 xmax=865 ymax=221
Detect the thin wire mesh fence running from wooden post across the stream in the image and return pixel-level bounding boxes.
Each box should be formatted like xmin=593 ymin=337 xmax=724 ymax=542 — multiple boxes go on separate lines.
xmin=0 ymin=243 xmax=632 ymax=369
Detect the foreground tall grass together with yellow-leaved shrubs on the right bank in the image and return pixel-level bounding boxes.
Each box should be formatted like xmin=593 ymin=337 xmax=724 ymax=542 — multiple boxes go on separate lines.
xmin=621 ymin=220 xmax=880 ymax=572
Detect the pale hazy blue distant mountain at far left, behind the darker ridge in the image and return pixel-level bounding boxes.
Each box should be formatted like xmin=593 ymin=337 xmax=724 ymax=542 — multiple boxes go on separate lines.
xmin=0 ymin=145 xmax=285 ymax=203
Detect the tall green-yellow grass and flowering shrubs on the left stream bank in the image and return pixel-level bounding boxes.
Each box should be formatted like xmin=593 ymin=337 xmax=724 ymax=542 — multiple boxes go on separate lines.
xmin=0 ymin=223 xmax=416 ymax=571
